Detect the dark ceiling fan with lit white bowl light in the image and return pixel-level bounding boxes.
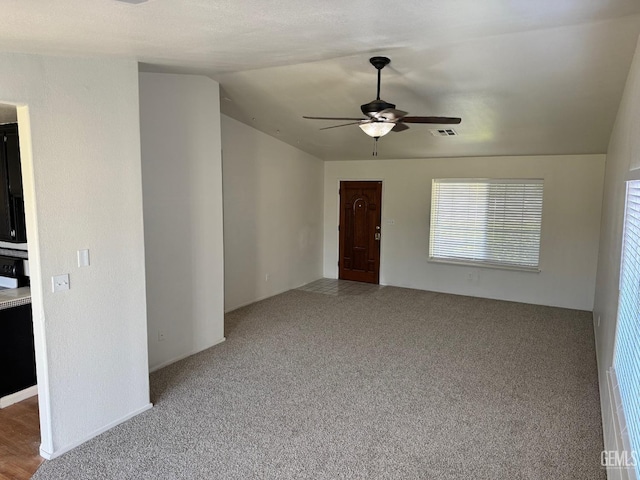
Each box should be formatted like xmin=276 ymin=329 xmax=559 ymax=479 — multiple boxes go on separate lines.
xmin=303 ymin=57 xmax=462 ymax=141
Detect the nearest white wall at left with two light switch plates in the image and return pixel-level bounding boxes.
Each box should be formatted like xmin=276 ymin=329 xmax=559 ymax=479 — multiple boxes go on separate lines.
xmin=0 ymin=54 xmax=150 ymax=457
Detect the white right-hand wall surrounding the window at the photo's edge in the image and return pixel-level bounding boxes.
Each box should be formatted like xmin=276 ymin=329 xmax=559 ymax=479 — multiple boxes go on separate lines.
xmin=593 ymin=34 xmax=640 ymax=479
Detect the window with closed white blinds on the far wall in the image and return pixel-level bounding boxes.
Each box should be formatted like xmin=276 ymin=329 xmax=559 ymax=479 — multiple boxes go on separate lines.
xmin=429 ymin=178 xmax=543 ymax=271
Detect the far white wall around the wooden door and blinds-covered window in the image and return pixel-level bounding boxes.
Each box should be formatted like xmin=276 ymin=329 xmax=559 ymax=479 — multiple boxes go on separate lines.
xmin=324 ymin=155 xmax=604 ymax=310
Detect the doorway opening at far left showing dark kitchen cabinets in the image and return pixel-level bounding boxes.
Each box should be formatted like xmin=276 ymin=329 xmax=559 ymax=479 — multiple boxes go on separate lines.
xmin=0 ymin=103 xmax=47 ymax=479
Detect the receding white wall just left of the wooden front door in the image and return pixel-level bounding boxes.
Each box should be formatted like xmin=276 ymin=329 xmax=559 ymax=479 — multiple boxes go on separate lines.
xmin=222 ymin=115 xmax=323 ymax=311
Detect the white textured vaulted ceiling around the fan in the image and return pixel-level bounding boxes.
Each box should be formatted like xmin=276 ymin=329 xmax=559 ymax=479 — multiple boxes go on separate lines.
xmin=0 ymin=0 xmax=640 ymax=159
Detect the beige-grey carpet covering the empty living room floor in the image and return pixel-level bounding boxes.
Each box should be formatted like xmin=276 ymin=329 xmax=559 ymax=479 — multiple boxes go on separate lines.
xmin=34 ymin=287 xmax=605 ymax=480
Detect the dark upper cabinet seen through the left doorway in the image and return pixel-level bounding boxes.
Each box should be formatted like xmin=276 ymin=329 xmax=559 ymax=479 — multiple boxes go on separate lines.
xmin=0 ymin=123 xmax=27 ymax=243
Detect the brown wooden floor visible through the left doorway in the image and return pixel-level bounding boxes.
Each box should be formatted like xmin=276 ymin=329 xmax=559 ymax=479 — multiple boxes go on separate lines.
xmin=0 ymin=396 xmax=44 ymax=480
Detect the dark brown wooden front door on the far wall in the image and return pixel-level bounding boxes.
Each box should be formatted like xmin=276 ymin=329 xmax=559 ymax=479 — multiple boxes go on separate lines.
xmin=339 ymin=182 xmax=382 ymax=283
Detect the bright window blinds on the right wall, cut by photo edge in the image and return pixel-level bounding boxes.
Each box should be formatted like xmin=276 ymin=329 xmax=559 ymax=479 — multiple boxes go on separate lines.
xmin=613 ymin=181 xmax=640 ymax=478
